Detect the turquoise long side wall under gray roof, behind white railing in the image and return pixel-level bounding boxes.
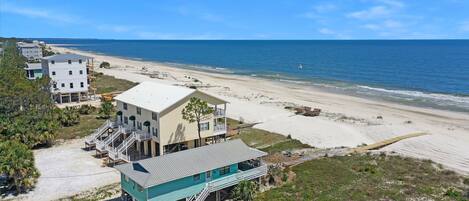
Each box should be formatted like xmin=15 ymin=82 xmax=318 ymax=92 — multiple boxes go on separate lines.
xmin=148 ymin=164 xmax=238 ymax=201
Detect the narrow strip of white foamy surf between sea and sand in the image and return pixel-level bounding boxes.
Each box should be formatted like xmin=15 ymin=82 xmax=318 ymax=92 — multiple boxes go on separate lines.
xmin=53 ymin=44 xmax=469 ymax=115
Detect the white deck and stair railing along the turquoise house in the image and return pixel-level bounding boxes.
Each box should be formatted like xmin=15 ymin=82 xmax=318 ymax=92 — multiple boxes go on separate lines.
xmin=186 ymin=165 xmax=268 ymax=201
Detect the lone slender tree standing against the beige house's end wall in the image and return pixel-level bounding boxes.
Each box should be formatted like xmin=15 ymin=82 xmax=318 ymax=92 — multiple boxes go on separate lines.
xmin=182 ymin=97 xmax=213 ymax=146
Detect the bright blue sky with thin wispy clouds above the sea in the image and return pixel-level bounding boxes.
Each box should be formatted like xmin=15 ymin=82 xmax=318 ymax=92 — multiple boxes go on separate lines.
xmin=0 ymin=0 xmax=469 ymax=39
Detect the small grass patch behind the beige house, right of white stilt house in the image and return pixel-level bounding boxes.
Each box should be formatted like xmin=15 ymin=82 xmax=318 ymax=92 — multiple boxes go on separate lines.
xmin=95 ymin=73 xmax=137 ymax=94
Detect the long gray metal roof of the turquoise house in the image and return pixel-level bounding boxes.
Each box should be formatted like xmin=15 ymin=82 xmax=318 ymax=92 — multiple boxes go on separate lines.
xmin=115 ymin=139 xmax=267 ymax=188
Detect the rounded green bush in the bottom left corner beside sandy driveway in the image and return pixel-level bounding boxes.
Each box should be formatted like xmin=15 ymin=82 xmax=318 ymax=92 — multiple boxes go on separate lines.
xmin=0 ymin=140 xmax=39 ymax=193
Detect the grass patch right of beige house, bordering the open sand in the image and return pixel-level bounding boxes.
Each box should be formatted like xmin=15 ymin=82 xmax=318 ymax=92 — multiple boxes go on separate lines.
xmin=227 ymin=119 xmax=310 ymax=153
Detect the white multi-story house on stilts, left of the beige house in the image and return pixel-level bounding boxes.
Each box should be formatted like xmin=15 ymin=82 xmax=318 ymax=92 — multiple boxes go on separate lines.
xmin=42 ymin=54 xmax=93 ymax=103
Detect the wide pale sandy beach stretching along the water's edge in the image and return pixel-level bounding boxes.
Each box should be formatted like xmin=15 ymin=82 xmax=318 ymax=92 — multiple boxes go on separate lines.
xmin=53 ymin=46 xmax=469 ymax=174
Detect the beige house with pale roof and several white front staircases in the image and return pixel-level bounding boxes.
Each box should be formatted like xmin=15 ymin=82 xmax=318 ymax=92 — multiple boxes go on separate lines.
xmin=86 ymin=82 xmax=227 ymax=162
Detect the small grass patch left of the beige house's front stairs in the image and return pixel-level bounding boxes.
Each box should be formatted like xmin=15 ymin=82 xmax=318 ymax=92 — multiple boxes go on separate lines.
xmin=56 ymin=113 xmax=105 ymax=140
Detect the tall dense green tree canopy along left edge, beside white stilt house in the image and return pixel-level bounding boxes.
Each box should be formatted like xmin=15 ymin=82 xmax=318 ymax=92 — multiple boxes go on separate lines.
xmin=0 ymin=40 xmax=59 ymax=147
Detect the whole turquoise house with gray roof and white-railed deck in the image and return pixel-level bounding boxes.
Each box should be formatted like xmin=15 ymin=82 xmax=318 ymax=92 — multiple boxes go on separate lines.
xmin=116 ymin=140 xmax=267 ymax=201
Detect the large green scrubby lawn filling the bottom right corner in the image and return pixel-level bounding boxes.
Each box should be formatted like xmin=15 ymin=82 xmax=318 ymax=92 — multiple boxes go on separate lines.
xmin=256 ymin=155 xmax=469 ymax=201
